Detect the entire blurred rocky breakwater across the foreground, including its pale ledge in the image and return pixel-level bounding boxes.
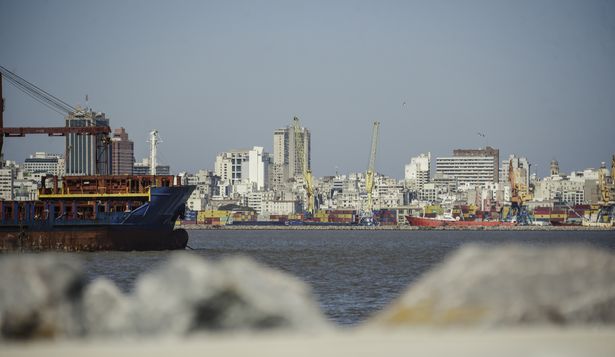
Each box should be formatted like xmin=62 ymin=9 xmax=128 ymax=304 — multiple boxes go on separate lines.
xmin=0 ymin=246 xmax=615 ymax=356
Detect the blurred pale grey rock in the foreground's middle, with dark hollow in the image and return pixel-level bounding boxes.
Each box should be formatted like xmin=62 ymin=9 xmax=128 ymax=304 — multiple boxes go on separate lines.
xmin=133 ymin=253 xmax=329 ymax=335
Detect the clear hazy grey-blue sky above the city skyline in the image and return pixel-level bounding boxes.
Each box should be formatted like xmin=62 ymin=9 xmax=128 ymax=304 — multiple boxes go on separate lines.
xmin=0 ymin=0 xmax=615 ymax=178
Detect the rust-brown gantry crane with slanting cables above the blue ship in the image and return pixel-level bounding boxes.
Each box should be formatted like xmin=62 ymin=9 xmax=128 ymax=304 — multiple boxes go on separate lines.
xmin=0 ymin=66 xmax=111 ymax=174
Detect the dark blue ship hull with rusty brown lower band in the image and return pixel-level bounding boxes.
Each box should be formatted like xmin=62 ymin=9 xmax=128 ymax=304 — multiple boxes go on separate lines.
xmin=0 ymin=186 xmax=194 ymax=251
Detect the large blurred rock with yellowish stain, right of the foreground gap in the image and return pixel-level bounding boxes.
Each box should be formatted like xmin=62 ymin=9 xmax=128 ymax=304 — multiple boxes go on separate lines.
xmin=367 ymin=245 xmax=615 ymax=327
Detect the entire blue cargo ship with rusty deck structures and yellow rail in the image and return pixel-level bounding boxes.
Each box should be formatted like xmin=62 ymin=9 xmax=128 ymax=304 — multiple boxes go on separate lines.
xmin=0 ymin=175 xmax=194 ymax=251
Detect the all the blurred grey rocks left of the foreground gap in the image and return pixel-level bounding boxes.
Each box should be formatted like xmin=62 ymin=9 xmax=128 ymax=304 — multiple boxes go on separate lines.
xmin=0 ymin=253 xmax=330 ymax=340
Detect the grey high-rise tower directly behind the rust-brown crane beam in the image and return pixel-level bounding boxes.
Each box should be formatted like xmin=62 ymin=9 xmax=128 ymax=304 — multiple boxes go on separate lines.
xmin=66 ymin=107 xmax=111 ymax=175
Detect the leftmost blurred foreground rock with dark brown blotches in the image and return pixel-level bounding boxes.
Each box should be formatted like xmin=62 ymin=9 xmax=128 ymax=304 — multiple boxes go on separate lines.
xmin=0 ymin=254 xmax=85 ymax=339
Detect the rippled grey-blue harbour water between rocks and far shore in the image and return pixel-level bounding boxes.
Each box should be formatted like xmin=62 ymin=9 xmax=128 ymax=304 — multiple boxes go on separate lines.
xmin=79 ymin=230 xmax=615 ymax=325
